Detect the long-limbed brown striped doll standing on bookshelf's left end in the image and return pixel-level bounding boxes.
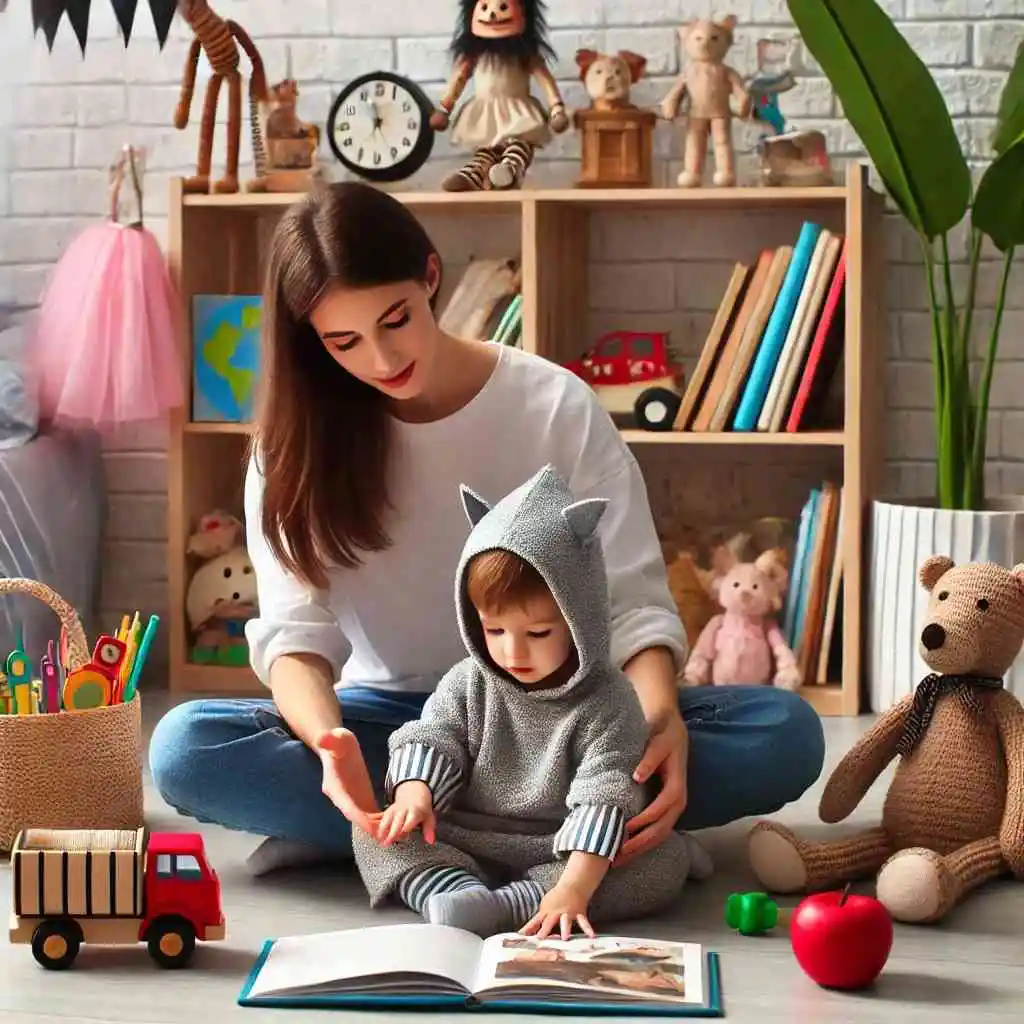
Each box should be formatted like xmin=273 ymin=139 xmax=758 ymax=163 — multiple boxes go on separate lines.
xmin=174 ymin=0 xmax=270 ymax=193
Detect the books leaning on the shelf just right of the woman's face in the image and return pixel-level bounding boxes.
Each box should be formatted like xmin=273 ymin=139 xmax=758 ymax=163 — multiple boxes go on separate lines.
xmin=439 ymin=258 xmax=522 ymax=345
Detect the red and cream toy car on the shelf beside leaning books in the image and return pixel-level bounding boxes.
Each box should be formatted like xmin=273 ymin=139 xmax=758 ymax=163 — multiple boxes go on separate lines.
xmin=564 ymin=331 xmax=683 ymax=430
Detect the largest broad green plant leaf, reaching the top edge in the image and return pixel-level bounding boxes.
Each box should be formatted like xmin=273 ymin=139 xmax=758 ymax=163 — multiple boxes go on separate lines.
xmin=787 ymin=0 xmax=971 ymax=239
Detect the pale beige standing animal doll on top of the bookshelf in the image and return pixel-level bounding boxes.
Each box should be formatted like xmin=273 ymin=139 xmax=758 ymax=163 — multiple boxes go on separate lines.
xmin=662 ymin=14 xmax=751 ymax=188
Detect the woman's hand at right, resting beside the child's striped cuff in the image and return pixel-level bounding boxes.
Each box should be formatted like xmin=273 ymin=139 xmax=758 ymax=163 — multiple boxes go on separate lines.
xmin=612 ymin=710 xmax=687 ymax=867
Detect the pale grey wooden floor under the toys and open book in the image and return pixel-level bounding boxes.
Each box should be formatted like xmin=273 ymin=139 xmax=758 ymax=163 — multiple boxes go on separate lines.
xmin=0 ymin=693 xmax=1024 ymax=1024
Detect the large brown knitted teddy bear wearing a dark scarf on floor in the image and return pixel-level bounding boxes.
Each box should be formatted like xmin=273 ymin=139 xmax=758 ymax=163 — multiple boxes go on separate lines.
xmin=749 ymin=555 xmax=1024 ymax=924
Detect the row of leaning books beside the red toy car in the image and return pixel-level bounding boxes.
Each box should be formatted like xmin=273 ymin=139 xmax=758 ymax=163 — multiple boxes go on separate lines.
xmin=674 ymin=221 xmax=846 ymax=432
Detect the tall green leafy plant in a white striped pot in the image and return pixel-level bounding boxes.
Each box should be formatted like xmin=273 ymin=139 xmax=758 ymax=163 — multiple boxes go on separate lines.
xmin=787 ymin=0 xmax=1024 ymax=712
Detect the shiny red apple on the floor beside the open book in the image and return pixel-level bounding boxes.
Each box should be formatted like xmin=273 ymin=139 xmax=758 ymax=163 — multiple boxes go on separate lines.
xmin=790 ymin=886 xmax=893 ymax=989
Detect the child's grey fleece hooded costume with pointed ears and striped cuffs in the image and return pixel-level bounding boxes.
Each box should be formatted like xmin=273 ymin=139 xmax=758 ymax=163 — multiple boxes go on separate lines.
xmin=353 ymin=466 xmax=690 ymax=922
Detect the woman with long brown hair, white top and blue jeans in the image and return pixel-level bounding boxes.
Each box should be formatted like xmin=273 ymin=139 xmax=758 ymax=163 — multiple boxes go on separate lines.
xmin=151 ymin=183 xmax=824 ymax=871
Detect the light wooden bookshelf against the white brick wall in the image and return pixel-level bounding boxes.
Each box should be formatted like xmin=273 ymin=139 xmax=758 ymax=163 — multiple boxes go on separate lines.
xmin=168 ymin=167 xmax=885 ymax=715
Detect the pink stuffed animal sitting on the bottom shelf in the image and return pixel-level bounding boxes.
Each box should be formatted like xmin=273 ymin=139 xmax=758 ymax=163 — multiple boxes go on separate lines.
xmin=683 ymin=551 xmax=802 ymax=690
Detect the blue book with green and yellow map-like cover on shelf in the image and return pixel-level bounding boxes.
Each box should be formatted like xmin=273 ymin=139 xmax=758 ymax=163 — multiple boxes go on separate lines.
xmin=191 ymin=295 xmax=262 ymax=423
